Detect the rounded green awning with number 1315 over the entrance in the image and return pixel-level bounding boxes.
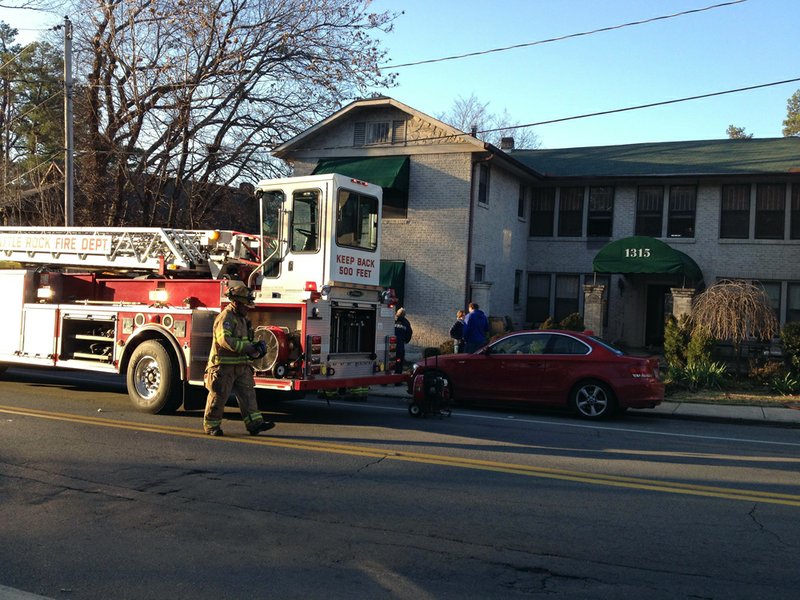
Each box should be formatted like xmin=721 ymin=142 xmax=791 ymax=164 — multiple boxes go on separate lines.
xmin=592 ymin=235 xmax=703 ymax=283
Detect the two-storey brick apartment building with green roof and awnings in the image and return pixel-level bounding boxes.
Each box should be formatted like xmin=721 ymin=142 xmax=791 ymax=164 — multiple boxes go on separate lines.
xmin=274 ymin=97 xmax=800 ymax=356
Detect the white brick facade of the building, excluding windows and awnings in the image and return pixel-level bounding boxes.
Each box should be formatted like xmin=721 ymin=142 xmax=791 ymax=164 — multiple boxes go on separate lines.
xmin=276 ymin=99 xmax=800 ymax=352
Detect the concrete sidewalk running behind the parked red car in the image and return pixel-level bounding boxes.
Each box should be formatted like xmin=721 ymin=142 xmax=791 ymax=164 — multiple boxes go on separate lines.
xmin=369 ymin=385 xmax=800 ymax=427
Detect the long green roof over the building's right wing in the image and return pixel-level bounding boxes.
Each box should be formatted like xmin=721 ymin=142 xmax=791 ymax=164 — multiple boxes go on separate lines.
xmin=508 ymin=137 xmax=800 ymax=178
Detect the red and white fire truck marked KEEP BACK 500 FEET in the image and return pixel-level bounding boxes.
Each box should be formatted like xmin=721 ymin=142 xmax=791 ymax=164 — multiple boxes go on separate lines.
xmin=0 ymin=174 xmax=402 ymax=413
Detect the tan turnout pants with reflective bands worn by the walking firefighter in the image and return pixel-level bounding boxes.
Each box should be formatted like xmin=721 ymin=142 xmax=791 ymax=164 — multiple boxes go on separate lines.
xmin=203 ymin=364 xmax=264 ymax=432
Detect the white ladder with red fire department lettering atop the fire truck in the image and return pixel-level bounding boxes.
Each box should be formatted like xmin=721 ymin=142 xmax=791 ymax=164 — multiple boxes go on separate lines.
xmin=0 ymin=227 xmax=213 ymax=271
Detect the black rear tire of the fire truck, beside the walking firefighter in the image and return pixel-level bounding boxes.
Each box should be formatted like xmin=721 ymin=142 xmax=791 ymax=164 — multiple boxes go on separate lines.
xmin=126 ymin=340 xmax=182 ymax=415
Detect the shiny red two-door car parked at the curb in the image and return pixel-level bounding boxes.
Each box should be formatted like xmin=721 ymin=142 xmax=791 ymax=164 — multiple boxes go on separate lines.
xmin=408 ymin=330 xmax=664 ymax=419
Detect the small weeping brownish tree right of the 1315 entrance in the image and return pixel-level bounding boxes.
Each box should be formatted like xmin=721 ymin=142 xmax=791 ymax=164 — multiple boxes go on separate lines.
xmin=692 ymin=279 xmax=778 ymax=371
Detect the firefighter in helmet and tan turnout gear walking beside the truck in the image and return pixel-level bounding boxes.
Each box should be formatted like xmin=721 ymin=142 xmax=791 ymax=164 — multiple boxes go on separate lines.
xmin=203 ymin=283 xmax=275 ymax=436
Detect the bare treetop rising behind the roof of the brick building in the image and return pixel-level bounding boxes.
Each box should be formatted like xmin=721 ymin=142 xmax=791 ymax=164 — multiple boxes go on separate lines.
xmin=436 ymin=94 xmax=542 ymax=150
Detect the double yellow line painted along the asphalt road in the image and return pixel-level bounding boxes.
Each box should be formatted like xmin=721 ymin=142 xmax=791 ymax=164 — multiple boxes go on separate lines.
xmin=0 ymin=406 xmax=800 ymax=507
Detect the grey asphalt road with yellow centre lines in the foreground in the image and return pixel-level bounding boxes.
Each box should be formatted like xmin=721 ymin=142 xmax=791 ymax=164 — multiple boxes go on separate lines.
xmin=0 ymin=370 xmax=800 ymax=600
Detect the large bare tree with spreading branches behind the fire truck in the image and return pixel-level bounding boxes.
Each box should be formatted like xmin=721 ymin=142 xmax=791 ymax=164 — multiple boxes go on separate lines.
xmin=69 ymin=0 xmax=394 ymax=227
